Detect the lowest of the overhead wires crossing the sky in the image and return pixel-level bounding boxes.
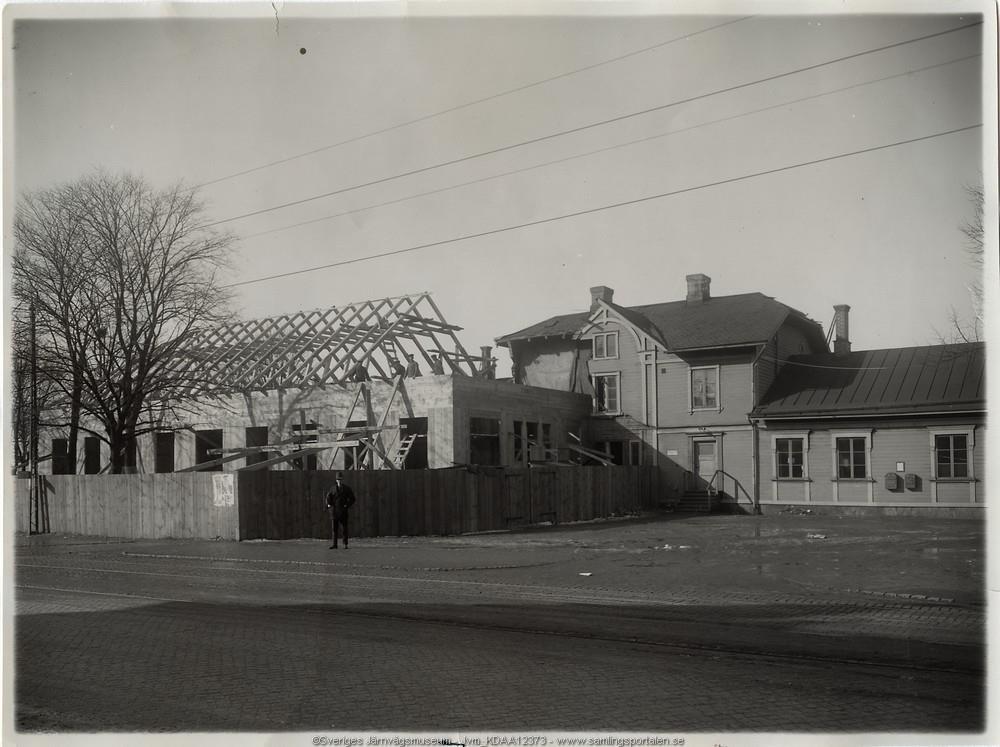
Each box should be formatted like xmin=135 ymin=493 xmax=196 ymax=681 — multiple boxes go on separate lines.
xmin=223 ymin=123 xmax=983 ymax=288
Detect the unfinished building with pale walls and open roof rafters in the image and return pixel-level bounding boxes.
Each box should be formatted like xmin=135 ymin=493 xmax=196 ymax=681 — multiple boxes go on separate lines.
xmin=50 ymin=293 xmax=591 ymax=473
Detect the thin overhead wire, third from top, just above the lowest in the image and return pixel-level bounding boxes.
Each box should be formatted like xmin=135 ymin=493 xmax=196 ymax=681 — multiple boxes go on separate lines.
xmin=241 ymin=53 xmax=982 ymax=240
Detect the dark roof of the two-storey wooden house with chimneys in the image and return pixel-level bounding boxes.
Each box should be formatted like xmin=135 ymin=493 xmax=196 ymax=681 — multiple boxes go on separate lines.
xmin=496 ymin=293 xmax=826 ymax=351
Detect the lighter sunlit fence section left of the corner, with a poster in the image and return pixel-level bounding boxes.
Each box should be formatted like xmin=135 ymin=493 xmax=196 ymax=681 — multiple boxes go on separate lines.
xmin=14 ymin=473 xmax=239 ymax=540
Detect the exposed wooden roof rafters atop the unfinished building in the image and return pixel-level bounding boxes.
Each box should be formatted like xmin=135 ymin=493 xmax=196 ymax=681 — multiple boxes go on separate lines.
xmin=176 ymin=292 xmax=484 ymax=397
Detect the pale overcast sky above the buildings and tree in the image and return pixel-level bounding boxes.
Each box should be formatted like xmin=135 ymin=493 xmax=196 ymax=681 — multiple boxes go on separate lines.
xmin=6 ymin=3 xmax=995 ymax=375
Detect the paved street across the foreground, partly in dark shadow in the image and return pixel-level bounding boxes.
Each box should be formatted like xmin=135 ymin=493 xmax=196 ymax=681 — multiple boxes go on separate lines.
xmin=16 ymin=534 xmax=985 ymax=734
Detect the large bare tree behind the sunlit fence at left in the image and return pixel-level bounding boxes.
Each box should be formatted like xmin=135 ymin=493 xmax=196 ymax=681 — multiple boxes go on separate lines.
xmin=13 ymin=173 xmax=232 ymax=472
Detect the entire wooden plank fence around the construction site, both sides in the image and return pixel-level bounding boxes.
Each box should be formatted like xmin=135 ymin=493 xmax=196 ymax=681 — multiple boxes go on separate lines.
xmin=14 ymin=466 xmax=655 ymax=540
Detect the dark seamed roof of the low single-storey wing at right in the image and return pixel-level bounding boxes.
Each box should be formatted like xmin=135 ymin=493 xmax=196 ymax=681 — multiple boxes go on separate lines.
xmin=752 ymin=342 xmax=986 ymax=419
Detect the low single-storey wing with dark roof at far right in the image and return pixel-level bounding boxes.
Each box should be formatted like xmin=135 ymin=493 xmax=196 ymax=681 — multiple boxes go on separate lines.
xmin=751 ymin=343 xmax=986 ymax=509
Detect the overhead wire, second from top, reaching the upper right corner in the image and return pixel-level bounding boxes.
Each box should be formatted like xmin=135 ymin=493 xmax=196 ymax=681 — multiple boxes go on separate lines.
xmin=200 ymin=21 xmax=983 ymax=228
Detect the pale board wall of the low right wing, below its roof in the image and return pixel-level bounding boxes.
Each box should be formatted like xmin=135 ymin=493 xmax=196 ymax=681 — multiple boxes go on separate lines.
xmin=760 ymin=419 xmax=986 ymax=508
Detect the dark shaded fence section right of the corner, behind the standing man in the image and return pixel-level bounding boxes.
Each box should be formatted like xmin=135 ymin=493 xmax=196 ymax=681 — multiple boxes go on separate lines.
xmin=237 ymin=467 xmax=655 ymax=539
